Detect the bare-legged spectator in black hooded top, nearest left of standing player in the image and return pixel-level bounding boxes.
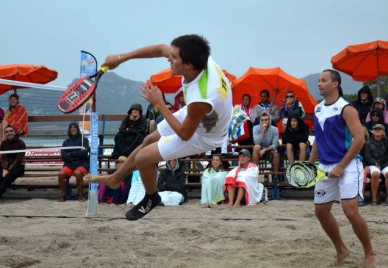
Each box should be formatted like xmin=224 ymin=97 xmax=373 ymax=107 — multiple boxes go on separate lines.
xmin=282 ymin=113 xmax=310 ymax=164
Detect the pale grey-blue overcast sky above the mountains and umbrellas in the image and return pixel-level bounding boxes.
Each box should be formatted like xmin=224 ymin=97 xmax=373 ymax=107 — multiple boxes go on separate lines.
xmin=0 ymin=0 xmax=388 ymax=86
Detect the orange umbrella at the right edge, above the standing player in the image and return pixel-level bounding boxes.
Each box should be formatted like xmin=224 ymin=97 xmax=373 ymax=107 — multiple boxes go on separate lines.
xmin=331 ymin=40 xmax=388 ymax=96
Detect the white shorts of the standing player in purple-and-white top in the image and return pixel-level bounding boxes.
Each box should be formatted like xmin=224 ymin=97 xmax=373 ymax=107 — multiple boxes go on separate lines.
xmin=314 ymin=159 xmax=364 ymax=204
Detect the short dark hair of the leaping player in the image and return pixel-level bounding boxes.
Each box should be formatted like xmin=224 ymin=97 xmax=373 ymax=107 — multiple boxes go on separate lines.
xmin=171 ymin=34 xmax=210 ymax=70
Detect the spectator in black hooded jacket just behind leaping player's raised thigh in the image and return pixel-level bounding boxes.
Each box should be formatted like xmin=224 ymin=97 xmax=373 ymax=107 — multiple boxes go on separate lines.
xmin=112 ymin=103 xmax=147 ymax=159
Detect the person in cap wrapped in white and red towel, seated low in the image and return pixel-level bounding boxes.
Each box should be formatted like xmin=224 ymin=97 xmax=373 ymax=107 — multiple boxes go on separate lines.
xmin=222 ymin=149 xmax=264 ymax=207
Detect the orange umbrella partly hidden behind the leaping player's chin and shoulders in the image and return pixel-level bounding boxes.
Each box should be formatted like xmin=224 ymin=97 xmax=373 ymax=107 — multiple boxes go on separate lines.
xmin=150 ymin=68 xmax=236 ymax=94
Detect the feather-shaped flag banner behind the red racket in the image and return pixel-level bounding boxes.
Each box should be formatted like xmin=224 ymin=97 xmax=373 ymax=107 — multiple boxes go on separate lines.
xmin=78 ymin=50 xmax=97 ymax=134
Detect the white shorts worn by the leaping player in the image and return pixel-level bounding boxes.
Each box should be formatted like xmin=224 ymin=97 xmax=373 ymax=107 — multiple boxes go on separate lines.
xmin=158 ymin=107 xmax=228 ymax=160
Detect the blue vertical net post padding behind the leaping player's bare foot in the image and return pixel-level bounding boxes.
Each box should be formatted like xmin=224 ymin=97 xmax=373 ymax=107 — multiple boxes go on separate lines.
xmin=88 ymin=112 xmax=99 ymax=214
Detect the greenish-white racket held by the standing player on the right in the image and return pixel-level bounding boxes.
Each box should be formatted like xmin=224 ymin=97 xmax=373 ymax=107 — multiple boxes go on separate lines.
xmin=286 ymin=161 xmax=328 ymax=188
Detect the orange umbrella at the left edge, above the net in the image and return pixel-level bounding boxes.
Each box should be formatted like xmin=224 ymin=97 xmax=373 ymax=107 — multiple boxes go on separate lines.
xmin=0 ymin=64 xmax=58 ymax=95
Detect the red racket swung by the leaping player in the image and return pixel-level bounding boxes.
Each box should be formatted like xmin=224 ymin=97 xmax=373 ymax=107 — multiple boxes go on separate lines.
xmin=58 ymin=66 xmax=109 ymax=114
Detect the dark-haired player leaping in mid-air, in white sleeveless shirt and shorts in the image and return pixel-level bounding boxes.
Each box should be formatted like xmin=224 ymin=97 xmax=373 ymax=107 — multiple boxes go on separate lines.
xmin=89 ymin=34 xmax=232 ymax=220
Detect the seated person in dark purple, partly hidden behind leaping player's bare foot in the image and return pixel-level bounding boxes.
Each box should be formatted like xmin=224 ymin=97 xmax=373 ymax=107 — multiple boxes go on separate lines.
xmin=98 ymin=155 xmax=132 ymax=205
